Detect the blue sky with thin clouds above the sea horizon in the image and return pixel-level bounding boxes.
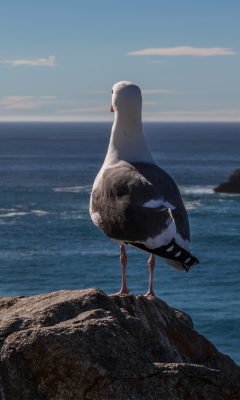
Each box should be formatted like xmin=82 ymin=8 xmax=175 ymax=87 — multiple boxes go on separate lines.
xmin=0 ymin=0 xmax=240 ymax=122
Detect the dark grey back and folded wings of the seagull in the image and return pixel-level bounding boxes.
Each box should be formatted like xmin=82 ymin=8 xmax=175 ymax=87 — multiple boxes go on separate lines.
xmin=92 ymin=162 xmax=190 ymax=242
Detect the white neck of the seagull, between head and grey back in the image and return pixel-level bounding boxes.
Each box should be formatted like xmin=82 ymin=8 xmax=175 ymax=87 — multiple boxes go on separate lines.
xmin=103 ymin=110 xmax=156 ymax=168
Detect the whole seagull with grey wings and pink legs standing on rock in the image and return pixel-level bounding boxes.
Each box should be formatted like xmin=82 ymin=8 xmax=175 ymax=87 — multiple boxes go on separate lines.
xmin=89 ymin=81 xmax=199 ymax=296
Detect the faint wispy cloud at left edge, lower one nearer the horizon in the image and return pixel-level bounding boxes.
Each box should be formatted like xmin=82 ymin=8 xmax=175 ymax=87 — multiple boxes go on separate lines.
xmin=0 ymin=96 xmax=56 ymax=110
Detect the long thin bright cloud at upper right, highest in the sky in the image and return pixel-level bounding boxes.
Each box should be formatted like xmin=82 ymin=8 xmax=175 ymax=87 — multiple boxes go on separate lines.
xmin=126 ymin=46 xmax=237 ymax=57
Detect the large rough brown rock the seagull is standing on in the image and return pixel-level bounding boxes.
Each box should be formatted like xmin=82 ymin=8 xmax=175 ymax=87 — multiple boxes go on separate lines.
xmin=0 ymin=289 xmax=240 ymax=400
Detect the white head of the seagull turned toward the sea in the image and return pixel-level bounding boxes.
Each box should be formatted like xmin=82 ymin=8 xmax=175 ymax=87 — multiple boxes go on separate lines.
xmin=110 ymin=81 xmax=142 ymax=119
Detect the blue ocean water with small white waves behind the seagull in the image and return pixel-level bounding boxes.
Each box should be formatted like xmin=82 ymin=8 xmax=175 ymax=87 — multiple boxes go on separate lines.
xmin=0 ymin=123 xmax=240 ymax=364
